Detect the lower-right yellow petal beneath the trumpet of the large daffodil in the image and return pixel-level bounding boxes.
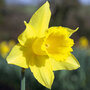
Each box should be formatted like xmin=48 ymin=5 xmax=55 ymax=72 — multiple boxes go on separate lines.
xmin=50 ymin=55 xmax=80 ymax=71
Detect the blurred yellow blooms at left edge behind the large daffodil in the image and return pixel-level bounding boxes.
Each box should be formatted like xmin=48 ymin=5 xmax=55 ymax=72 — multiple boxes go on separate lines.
xmin=0 ymin=40 xmax=15 ymax=58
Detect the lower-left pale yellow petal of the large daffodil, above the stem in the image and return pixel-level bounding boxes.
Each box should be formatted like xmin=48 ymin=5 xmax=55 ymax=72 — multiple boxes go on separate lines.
xmin=6 ymin=44 xmax=28 ymax=68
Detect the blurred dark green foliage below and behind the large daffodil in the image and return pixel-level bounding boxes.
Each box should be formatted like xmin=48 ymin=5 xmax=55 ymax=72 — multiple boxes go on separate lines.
xmin=0 ymin=47 xmax=90 ymax=90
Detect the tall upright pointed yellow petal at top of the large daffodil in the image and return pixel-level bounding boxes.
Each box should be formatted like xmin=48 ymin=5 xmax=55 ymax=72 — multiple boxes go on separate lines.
xmin=29 ymin=1 xmax=51 ymax=37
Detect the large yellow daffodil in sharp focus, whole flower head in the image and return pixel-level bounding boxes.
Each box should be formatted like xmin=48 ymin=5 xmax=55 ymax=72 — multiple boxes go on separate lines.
xmin=7 ymin=2 xmax=80 ymax=88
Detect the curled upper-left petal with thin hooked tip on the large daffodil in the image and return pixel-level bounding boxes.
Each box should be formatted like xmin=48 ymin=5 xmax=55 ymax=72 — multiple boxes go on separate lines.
xmin=18 ymin=21 xmax=36 ymax=46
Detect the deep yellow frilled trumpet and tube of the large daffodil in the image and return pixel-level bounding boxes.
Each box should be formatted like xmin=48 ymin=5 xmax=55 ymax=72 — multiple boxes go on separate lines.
xmin=32 ymin=27 xmax=74 ymax=61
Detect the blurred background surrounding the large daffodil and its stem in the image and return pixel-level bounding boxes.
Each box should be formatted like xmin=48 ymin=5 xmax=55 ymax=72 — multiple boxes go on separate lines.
xmin=0 ymin=0 xmax=90 ymax=90
